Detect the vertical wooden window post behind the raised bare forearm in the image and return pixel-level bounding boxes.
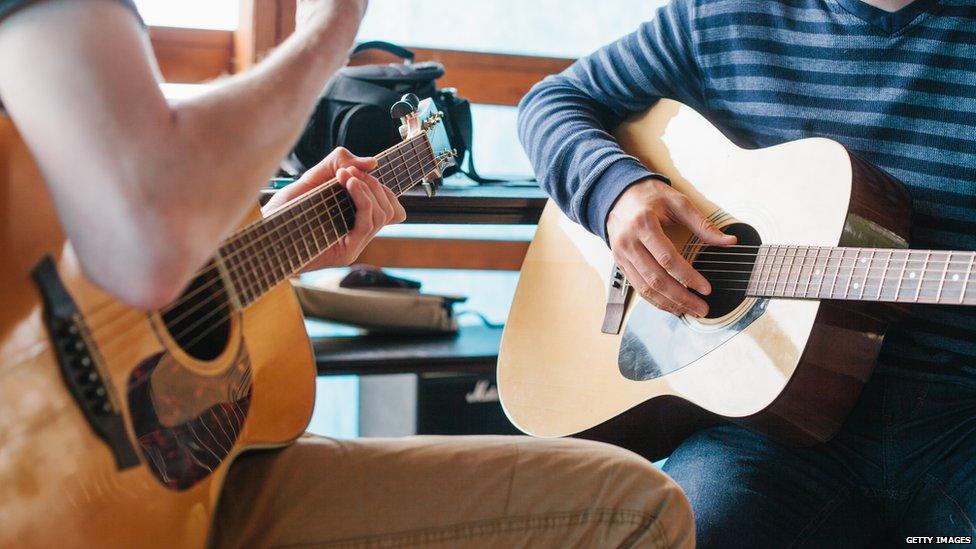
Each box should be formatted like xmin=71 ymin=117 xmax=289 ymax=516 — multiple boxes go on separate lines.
xmin=233 ymin=0 xmax=295 ymax=71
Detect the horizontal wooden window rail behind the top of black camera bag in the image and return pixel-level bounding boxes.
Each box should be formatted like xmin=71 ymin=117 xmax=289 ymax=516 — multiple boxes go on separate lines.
xmin=352 ymin=48 xmax=573 ymax=105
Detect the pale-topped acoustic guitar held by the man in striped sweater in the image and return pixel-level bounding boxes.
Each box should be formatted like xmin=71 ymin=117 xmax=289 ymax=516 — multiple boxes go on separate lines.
xmin=498 ymin=100 xmax=964 ymax=457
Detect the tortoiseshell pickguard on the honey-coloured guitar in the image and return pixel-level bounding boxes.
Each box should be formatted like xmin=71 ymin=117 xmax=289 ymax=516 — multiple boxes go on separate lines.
xmin=128 ymin=345 xmax=251 ymax=490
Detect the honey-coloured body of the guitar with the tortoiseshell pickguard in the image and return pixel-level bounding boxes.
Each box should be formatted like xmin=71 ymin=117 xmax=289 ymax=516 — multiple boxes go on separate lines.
xmin=0 ymin=117 xmax=315 ymax=547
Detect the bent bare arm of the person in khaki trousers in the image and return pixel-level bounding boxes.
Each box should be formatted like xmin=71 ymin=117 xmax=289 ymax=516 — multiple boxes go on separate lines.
xmin=0 ymin=0 xmax=365 ymax=308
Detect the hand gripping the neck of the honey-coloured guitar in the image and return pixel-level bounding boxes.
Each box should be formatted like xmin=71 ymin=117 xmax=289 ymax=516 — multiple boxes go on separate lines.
xmin=262 ymin=147 xmax=407 ymax=271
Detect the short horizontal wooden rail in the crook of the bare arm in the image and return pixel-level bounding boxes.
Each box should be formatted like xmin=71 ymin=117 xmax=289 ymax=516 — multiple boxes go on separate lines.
xmin=149 ymin=27 xmax=233 ymax=82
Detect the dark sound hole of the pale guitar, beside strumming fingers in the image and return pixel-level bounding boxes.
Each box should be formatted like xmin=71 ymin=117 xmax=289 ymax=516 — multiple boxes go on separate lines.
xmin=692 ymin=223 xmax=762 ymax=318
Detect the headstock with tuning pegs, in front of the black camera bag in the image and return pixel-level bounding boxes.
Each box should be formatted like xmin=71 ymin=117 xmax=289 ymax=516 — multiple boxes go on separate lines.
xmin=390 ymin=93 xmax=457 ymax=196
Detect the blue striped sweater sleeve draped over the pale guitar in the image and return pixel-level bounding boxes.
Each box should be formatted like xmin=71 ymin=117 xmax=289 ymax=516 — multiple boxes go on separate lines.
xmin=518 ymin=0 xmax=704 ymax=240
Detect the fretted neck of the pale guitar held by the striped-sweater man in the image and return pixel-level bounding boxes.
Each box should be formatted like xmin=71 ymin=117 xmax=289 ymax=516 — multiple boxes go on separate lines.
xmin=746 ymin=245 xmax=976 ymax=305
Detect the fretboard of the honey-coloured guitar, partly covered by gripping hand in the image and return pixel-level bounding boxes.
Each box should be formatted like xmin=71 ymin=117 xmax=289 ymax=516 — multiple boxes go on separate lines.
xmin=217 ymin=135 xmax=435 ymax=308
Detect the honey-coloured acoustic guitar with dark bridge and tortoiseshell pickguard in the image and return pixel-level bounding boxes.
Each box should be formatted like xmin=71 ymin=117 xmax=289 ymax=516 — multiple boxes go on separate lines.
xmin=0 ymin=97 xmax=453 ymax=548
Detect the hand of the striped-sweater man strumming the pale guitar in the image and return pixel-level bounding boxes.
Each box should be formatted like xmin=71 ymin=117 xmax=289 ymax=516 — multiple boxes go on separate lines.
xmin=607 ymin=179 xmax=735 ymax=317
